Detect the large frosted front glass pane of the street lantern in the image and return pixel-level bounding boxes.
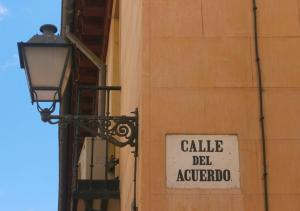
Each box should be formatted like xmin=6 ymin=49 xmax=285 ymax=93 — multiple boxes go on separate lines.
xmin=24 ymin=46 xmax=68 ymax=87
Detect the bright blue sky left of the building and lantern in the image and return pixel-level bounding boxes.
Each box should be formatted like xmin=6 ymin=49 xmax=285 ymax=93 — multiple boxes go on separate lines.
xmin=0 ymin=0 xmax=61 ymax=211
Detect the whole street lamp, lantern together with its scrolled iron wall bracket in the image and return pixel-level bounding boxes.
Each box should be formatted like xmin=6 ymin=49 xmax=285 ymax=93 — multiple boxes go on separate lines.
xmin=18 ymin=24 xmax=138 ymax=147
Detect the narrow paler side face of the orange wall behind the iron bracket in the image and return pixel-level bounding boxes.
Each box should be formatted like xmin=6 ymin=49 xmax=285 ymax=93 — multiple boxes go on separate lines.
xmin=120 ymin=0 xmax=142 ymax=210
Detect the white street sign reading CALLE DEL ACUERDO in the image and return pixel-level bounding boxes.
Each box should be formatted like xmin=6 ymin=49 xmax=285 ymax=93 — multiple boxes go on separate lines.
xmin=166 ymin=135 xmax=240 ymax=189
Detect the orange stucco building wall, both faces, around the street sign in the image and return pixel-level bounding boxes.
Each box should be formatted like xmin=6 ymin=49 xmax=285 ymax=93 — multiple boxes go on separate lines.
xmin=120 ymin=0 xmax=300 ymax=211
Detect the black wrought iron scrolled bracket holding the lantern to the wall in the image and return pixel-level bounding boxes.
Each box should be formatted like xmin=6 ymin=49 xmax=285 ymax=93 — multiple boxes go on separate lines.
xmin=39 ymin=108 xmax=138 ymax=148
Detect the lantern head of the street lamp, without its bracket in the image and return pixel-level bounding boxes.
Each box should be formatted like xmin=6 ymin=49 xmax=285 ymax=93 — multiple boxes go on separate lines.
xmin=18 ymin=24 xmax=72 ymax=103
